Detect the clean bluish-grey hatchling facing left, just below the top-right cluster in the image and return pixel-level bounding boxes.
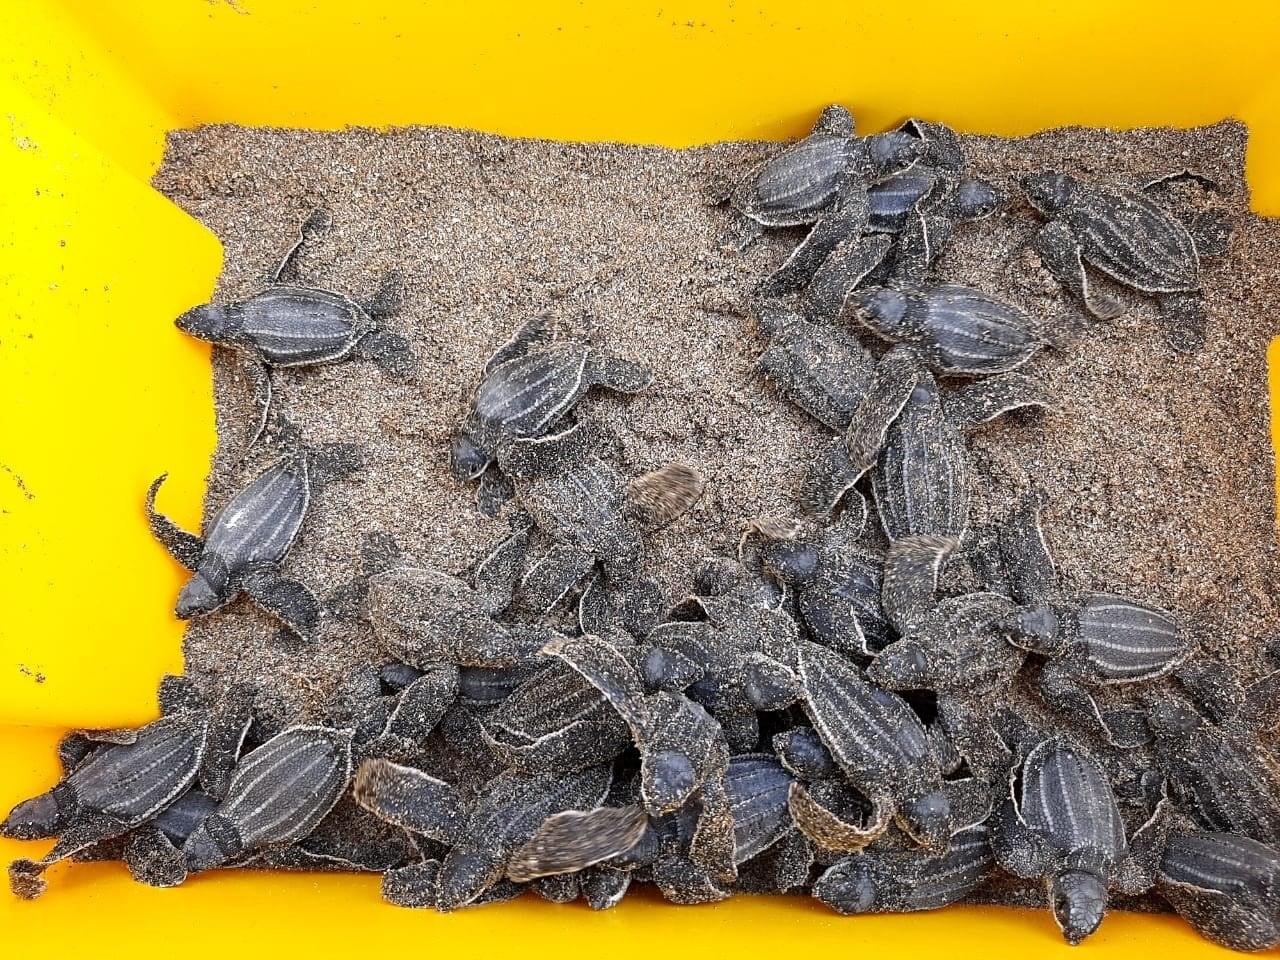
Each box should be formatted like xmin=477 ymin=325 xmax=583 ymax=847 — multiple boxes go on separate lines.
xmin=852 ymin=283 xmax=1044 ymax=376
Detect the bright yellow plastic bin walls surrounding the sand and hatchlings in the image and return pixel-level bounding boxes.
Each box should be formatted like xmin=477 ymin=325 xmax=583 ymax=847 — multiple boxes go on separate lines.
xmin=0 ymin=0 xmax=1280 ymax=957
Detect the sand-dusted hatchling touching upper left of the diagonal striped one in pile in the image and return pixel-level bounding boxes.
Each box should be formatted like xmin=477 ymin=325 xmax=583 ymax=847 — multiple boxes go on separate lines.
xmin=648 ymin=596 xmax=800 ymax=750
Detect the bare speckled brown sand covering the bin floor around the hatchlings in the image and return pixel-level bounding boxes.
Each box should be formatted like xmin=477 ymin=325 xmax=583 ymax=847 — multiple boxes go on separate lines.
xmin=155 ymin=123 xmax=1280 ymax=900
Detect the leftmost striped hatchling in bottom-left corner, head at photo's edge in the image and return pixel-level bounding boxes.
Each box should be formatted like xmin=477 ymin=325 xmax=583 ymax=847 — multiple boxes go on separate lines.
xmin=0 ymin=710 xmax=211 ymax=900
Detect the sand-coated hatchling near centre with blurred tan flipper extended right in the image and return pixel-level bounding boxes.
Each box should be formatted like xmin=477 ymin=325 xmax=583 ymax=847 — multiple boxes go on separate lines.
xmin=499 ymin=420 xmax=701 ymax=632
